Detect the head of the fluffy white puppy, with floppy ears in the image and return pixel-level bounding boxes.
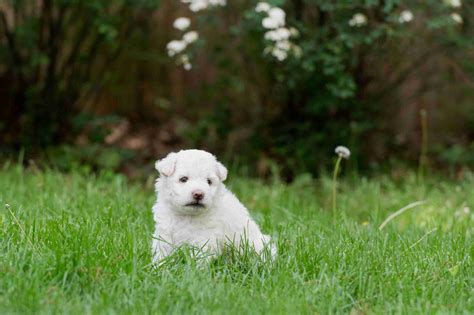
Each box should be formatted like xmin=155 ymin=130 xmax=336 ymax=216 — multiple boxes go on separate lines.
xmin=155 ymin=150 xmax=227 ymax=214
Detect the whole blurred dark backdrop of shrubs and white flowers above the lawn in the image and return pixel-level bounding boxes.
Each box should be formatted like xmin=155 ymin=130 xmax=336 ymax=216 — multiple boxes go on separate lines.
xmin=0 ymin=0 xmax=474 ymax=180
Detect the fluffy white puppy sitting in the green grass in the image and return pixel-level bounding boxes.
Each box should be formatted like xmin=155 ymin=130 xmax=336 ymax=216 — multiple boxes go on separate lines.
xmin=152 ymin=150 xmax=276 ymax=262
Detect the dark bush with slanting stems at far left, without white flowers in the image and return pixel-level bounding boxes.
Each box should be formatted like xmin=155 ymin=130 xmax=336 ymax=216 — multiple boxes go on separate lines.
xmin=0 ymin=0 xmax=158 ymax=147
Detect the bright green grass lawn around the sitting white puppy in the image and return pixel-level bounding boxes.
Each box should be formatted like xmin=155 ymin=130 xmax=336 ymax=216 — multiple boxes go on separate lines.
xmin=0 ymin=166 xmax=474 ymax=314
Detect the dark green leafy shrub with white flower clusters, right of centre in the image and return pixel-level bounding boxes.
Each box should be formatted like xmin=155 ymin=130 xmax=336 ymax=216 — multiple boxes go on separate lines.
xmin=162 ymin=0 xmax=471 ymax=174
